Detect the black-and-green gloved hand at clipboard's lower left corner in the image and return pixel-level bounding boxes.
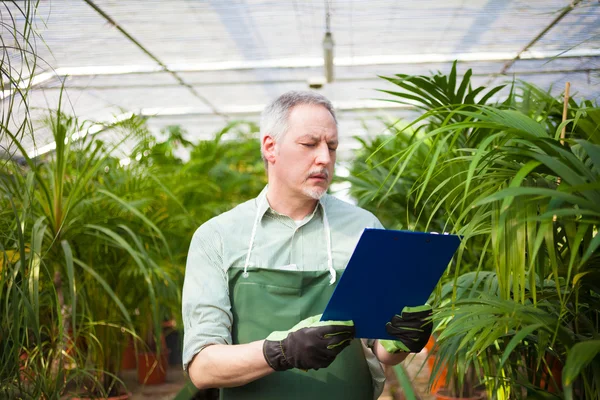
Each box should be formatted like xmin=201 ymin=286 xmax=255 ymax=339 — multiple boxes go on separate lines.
xmin=263 ymin=315 xmax=355 ymax=371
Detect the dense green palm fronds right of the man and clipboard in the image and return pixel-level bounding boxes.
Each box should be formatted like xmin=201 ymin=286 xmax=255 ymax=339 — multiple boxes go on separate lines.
xmin=352 ymin=61 xmax=600 ymax=399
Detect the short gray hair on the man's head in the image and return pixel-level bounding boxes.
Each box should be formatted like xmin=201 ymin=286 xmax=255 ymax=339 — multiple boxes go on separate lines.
xmin=260 ymin=90 xmax=337 ymax=160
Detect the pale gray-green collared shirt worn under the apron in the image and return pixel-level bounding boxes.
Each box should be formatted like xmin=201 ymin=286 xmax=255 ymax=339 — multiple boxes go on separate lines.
xmin=182 ymin=188 xmax=383 ymax=396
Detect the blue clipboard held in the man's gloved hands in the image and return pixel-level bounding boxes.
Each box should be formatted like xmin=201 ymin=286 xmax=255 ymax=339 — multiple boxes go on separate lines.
xmin=321 ymin=229 xmax=460 ymax=339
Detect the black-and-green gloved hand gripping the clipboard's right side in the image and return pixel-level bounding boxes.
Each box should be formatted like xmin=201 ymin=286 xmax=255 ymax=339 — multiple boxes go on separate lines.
xmin=379 ymin=304 xmax=433 ymax=353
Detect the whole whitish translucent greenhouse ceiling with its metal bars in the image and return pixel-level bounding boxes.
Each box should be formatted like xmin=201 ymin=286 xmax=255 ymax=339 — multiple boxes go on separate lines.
xmin=0 ymin=0 xmax=600 ymax=161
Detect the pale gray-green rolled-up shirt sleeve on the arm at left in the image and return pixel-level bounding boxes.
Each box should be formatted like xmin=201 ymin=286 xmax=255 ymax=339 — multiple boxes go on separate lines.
xmin=182 ymin=220 xmax=233 ymax=371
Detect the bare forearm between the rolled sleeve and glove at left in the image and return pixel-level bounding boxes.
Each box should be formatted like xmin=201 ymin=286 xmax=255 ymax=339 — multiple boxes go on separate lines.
xmin=188 ymin=340 xmax=275 ymax=389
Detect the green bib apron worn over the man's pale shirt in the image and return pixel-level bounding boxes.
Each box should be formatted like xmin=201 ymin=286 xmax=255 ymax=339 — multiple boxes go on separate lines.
xmin=221 ymin=268 xmax=373 ymax=400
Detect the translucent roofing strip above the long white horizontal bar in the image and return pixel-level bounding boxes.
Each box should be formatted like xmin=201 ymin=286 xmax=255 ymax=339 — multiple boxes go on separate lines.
xmin=5 ymin=0 xmax=600 ymax=68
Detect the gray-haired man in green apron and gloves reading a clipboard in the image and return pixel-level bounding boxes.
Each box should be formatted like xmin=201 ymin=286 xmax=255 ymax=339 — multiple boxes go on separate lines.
xmin=183 ymin=92 xmax=431 ymax=399
